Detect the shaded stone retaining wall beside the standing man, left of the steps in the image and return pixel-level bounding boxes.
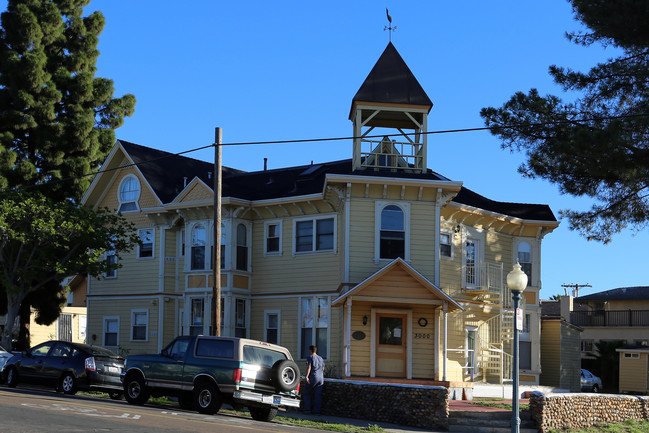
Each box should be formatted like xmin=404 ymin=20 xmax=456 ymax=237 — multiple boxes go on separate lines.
xmin=300 ymin=379 xmax=448 ymax=430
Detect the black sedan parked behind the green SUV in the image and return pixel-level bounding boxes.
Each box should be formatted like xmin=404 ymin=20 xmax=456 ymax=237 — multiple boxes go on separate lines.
xmin=3 ymin=341 xmax=124 ymax=399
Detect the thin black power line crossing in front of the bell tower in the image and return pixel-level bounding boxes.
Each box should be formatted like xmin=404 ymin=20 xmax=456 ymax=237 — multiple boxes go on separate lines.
xmin=1 ymin=113 xmax=649 ymax=193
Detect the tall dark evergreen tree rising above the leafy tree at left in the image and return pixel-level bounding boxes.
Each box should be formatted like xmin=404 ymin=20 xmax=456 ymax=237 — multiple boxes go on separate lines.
xmin=0 ymin=0 xmax=135 ymax=200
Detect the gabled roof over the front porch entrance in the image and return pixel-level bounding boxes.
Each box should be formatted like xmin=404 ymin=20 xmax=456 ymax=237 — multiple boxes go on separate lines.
xmin=332 ymin=258 xmax=464 ymax=312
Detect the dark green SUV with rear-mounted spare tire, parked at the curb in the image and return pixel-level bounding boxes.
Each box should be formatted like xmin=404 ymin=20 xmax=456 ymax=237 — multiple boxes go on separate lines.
xmin=121 ymin=335 xmax=300 ymax=421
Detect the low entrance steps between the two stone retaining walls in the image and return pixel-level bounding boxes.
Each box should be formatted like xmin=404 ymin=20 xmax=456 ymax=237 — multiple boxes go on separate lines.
xmin=448 ymin=410 xmax=539 ymax=433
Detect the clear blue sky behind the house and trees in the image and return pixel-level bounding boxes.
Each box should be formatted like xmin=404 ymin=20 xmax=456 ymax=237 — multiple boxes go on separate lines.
xmin=0 ymin=0 xmax=649 ymax=298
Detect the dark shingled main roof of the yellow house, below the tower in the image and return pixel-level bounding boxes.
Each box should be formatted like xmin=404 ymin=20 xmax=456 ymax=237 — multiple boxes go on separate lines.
xmin=119 ymin=140 xmax=556 ymax=221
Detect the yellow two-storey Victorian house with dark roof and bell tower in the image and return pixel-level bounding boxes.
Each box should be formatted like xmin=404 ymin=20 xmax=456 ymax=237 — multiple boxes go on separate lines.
xmin=83 ymin=43 xmax=558 ymax=384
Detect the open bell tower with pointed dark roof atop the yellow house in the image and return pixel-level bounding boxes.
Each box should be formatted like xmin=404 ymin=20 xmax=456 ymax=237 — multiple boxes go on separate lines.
xmin=349 ymin=42 xmax=433 ymax=173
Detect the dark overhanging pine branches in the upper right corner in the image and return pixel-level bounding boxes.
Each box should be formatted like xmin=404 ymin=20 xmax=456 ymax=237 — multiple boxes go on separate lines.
xmin=480 ymin=0 xmax=649 ymax=243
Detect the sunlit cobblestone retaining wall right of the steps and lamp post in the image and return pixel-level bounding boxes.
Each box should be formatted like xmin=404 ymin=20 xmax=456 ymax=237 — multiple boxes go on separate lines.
xmin=530 ymin=392 xmax=649 ymax=433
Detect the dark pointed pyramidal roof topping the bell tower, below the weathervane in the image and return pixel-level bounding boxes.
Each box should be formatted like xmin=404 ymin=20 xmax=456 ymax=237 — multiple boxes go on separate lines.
xmin=353 ymin=42 xmax=433 ymax=107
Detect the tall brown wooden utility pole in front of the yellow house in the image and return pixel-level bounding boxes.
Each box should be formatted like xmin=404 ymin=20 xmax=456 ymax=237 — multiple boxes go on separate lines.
xmin=212 ymin=127 xmax=223 ymax=337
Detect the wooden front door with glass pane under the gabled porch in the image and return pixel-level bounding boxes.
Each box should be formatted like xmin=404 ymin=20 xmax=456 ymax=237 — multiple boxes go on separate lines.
xmin=375 ymin=313 xmax=408 ymax=377
